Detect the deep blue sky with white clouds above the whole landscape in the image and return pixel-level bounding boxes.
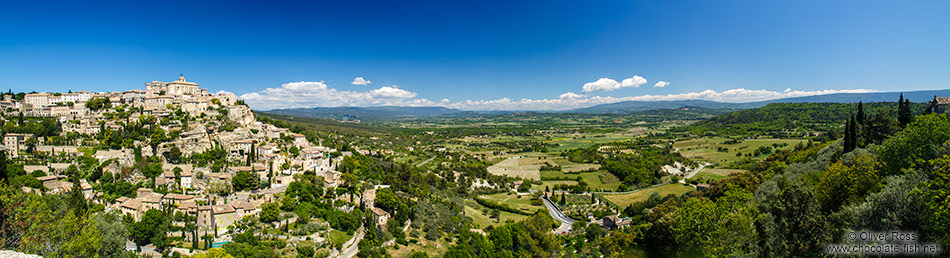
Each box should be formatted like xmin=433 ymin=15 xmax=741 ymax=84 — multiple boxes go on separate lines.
xmin=0 ymin=1 xmax=950 ymax=110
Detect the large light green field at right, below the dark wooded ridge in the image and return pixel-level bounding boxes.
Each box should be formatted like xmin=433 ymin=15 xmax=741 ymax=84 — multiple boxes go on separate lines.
xmin=673 ymin=138 xmax=805 ymax=164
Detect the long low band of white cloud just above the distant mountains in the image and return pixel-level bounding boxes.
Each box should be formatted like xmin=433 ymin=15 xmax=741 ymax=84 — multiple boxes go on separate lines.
xmin=240 ymin=79 xmax=875 ymax=110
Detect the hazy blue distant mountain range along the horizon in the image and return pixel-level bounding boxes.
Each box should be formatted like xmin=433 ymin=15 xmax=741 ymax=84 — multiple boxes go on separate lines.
xmin=262 ymin=89 xmax=950 ymax=121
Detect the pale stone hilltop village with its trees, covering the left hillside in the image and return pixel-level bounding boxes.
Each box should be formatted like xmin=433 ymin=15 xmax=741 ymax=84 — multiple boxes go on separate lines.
xmin=0 ymin=76 xmax=389 ymax=254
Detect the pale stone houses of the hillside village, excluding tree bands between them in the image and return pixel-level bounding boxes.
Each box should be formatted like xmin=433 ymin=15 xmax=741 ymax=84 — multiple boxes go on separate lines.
xmin=6 ymin=76 xmax=364 ymax=238
